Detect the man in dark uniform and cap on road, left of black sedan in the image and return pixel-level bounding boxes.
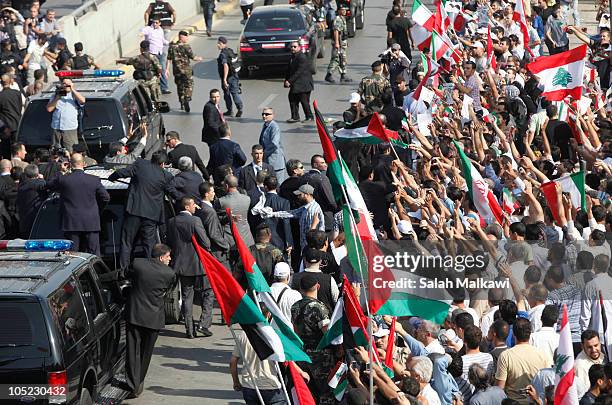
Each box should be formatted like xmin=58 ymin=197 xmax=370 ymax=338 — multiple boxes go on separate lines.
xmin=217 ymin=37 xmax=242 ymax=118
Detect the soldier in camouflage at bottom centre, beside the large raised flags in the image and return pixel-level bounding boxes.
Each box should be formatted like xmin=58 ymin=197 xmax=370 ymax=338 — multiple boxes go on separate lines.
xmin=291 ymin=274 xmax=337 ymax=405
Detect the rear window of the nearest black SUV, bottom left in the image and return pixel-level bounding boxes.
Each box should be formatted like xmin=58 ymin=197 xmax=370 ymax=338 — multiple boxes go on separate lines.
xmin=0 ymin=299 xmax=49 ymax=356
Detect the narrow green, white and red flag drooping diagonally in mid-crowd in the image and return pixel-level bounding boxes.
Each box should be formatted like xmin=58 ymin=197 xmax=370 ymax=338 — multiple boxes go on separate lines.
xmin=453 ymin=141 xmax=503 ymax=225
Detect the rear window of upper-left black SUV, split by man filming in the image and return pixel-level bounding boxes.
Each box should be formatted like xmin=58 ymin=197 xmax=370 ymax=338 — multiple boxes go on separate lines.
xmin=19 ymin=99 xmax=123 ymax=145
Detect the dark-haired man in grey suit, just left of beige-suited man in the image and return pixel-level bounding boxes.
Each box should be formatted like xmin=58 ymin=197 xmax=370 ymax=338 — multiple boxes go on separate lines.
xmin=196 ymin=181 xmax=234 ymax=270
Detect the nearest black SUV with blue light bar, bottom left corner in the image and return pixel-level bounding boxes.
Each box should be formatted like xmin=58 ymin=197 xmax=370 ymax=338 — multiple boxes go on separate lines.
xmin=0 ymin=240 xmax=125 ymax=404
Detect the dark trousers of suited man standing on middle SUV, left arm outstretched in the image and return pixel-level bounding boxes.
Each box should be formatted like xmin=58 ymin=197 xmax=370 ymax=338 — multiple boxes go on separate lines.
xmin=119 ymin=213 xmax=157 ymax=269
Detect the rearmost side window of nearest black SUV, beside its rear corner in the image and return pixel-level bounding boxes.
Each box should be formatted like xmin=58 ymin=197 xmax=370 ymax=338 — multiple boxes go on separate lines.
xmin=49 ymin=278 xmax=89 ymax=351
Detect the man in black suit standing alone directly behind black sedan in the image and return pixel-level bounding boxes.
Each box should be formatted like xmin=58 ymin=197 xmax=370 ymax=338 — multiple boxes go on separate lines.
xmin=285 ymin=42 xmax=314 ymax=123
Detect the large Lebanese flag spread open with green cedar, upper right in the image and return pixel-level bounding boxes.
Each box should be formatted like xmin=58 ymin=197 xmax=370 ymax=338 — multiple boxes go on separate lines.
xmin=517 ymin=44 xmax=587 ymax=101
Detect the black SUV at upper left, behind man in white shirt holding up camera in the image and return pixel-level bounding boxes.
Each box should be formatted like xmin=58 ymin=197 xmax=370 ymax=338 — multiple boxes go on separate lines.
xmin=17 ymin=77 xmax=169 ymax=161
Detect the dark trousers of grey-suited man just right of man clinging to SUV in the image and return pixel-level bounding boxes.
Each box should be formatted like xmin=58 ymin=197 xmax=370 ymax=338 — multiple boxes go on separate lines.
xmin=179 ymin=276 xmax=214 ymax=335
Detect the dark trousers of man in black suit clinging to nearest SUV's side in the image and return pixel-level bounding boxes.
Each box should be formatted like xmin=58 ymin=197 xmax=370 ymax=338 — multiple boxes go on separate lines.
xmin=125 ymin=322 xmax=159 ymax=394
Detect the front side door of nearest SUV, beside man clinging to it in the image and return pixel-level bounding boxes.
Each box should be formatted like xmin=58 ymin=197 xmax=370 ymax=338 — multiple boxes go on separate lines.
xmin=77 ymin=266 xmax=115 ymax=386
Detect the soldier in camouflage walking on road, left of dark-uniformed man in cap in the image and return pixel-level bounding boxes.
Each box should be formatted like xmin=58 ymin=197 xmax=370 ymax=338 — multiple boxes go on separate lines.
xmin=166 ymin=31 xmax=202 ymax=112
